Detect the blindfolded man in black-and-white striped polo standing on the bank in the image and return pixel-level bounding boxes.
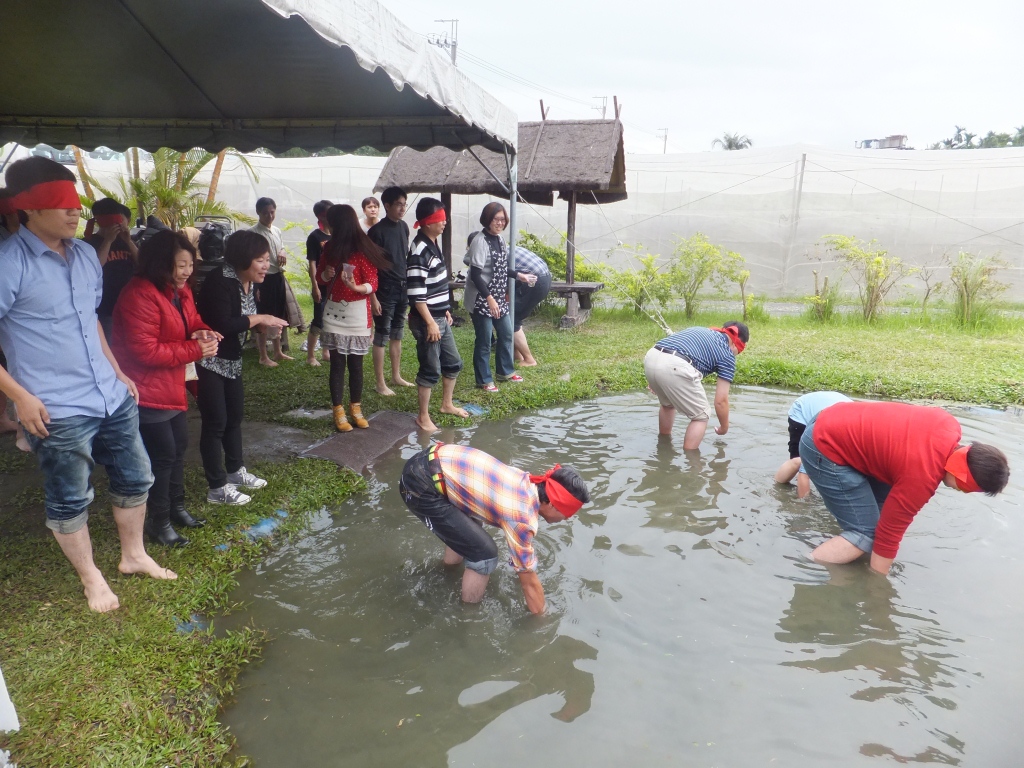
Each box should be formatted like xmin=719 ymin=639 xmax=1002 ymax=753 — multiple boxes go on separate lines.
xmin=406 ymin=198 xmax=469 ymax=432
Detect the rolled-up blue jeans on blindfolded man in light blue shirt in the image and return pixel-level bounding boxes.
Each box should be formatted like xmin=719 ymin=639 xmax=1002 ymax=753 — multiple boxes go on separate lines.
xmin=27 ymin=395 xmax=154 ymax=534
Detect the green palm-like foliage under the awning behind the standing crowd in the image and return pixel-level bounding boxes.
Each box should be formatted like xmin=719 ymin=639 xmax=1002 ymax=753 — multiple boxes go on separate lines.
xmin=89 ymin=147 xmax=258 ymax=229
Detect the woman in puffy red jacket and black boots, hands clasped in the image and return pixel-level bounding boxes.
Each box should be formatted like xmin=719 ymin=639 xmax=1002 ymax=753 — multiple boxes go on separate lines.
xmin=111 ymin=230 xmax=220 ymax=547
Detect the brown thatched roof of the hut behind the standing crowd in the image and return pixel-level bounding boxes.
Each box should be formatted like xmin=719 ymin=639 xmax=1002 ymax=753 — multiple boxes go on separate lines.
xmin=374 ymin=120 xmax=626 ymax=206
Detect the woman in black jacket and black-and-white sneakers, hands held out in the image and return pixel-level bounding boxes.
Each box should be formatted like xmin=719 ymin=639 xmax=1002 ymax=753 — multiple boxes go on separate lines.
xmin=196 ymin=230 xmax=288 ymax=505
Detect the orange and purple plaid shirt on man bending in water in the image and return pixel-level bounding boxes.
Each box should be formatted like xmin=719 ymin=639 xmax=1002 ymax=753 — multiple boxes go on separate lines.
xmin=437 ymin=445 xmax=541 ymax=572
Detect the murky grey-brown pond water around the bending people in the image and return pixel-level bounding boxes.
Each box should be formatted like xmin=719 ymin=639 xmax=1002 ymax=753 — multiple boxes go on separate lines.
xmin=225 ymin=388 xmax=1024 ymax=768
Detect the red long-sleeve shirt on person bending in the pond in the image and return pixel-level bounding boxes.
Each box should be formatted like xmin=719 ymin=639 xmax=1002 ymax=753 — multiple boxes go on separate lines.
xmin=814 ymin=402 xmax=962 ymax=557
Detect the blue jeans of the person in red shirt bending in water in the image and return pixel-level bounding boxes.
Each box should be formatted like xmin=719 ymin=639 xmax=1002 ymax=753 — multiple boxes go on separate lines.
xmin=800 ymin=420 xmax=892 ymax=552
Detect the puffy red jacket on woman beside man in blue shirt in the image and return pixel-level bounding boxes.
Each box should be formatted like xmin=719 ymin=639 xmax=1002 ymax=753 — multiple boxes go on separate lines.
xmin=111 ymin=278 xmax=210 ymax=411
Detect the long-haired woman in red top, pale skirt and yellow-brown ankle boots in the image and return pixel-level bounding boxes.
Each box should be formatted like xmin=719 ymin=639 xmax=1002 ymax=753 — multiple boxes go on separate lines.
xmin=316 ymin=205 xmax=391 ymax=432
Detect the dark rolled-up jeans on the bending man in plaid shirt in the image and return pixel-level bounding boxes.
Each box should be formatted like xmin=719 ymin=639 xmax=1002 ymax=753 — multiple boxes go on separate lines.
xmin=398 ymin=449 xmax=498 ymax=575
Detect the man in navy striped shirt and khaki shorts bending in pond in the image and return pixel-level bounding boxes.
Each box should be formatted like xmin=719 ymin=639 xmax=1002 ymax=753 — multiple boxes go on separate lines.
xmin=643 ymin=321 xmax=751 ymax=451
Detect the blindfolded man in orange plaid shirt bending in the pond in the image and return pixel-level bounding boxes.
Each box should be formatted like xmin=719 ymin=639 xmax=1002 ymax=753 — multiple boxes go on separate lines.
xmin=398 ymin=443 xmax=590 ymax=613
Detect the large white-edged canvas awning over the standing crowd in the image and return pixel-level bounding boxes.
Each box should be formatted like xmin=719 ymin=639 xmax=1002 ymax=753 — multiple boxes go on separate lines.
xmin=0 ymin=0 xmax=517 ymax=152
